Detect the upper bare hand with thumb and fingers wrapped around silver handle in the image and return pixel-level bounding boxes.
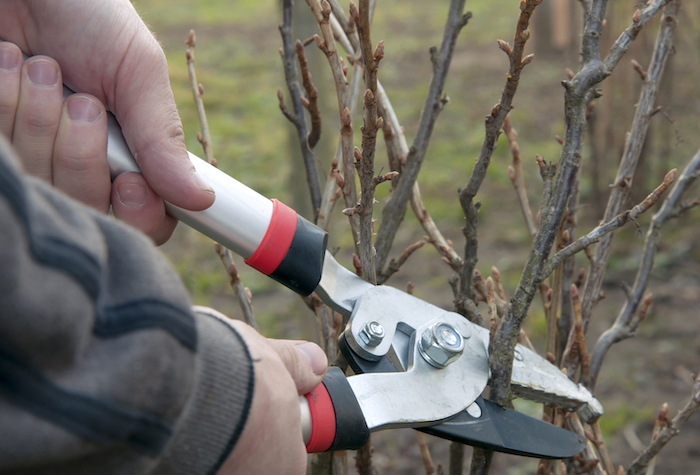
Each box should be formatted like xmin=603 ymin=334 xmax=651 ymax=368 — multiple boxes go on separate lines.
xmin=0 ymin=0 xmax=214 ymax=243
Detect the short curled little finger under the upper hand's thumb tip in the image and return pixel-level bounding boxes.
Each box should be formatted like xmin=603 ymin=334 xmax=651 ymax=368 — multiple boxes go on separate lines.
xmin=112 ymin=172 xmax=177 ymax=245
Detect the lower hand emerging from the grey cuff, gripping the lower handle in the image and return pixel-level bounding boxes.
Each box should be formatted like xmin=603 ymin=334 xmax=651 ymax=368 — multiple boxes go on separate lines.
xmin=219 ymin=321 xmax=328 ymax=475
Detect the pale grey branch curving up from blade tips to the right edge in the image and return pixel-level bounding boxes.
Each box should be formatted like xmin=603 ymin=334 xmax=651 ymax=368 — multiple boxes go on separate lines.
xmin=587 ymin=151 xmax=700 ymax=389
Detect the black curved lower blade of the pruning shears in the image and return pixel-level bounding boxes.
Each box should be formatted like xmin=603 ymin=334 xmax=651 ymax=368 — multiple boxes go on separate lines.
xmin=417 ymin=397 xmax=586 ymax=459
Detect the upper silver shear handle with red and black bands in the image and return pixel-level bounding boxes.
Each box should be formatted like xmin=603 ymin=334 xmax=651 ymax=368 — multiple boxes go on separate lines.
xmin=74 ymin=86 xmax=328 ymax=296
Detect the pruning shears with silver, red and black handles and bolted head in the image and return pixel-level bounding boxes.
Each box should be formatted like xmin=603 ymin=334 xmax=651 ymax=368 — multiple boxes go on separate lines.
xmin=102 ymin=97 xmax=603 ymax=459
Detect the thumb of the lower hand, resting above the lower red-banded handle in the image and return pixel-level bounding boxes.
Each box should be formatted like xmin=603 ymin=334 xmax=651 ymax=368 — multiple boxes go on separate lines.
xmin=267 ymin=339 xmax=328 ymax=395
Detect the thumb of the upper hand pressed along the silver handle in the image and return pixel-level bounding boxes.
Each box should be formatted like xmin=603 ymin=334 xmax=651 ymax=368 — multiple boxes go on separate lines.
xmin=108 ymin=25 xmax=214 ymax=210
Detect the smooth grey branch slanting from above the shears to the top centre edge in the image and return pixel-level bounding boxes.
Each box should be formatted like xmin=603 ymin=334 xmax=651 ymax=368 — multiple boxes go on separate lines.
xmin=375 ymin=0 xmax=471 ymax=276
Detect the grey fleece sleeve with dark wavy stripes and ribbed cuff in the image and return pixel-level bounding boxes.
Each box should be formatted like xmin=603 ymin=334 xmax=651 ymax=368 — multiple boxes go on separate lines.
xmin=0 ymin=137 xmax=254 ymax=474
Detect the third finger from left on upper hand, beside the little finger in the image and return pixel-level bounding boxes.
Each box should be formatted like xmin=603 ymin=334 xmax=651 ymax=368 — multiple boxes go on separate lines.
xmin=52 ymin=94 xmax=112 ymax=213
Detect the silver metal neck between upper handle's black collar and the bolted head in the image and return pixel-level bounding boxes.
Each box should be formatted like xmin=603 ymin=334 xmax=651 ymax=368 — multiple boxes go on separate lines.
xmin=316 ymin=251 xmax=374 ymax=317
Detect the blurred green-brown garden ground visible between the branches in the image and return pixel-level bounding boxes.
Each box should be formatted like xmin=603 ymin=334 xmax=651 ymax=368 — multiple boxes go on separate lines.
xmin=134 ymin=0 xmax=700 ymax=474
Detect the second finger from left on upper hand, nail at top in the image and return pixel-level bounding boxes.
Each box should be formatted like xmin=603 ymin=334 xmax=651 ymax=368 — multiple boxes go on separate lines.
xmin=12 ymin=56 xmax=63 ymax=183
